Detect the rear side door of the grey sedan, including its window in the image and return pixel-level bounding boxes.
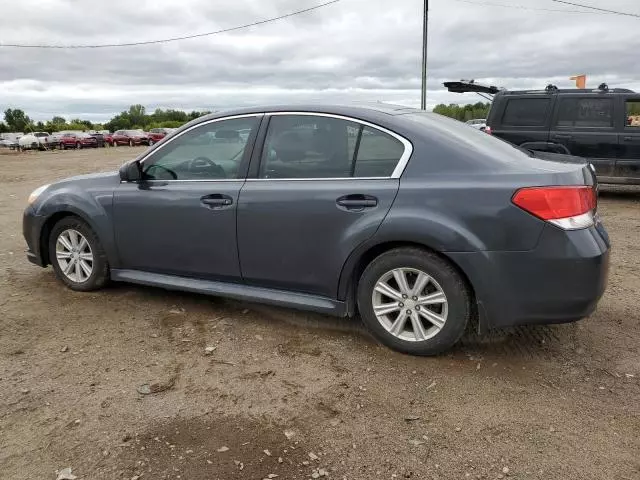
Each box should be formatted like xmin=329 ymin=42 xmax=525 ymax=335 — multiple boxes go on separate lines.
xmin=238 ymin=114 xmax=411 ymax=298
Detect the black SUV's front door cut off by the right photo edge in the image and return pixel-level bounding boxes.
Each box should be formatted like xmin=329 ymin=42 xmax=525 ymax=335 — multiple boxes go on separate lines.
xmin=614 ymin=95 xmax=640 ymax=183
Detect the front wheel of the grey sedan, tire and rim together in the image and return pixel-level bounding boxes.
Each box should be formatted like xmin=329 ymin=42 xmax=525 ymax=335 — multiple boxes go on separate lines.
xmin=49 ymin=217 xmax=109 ymax=292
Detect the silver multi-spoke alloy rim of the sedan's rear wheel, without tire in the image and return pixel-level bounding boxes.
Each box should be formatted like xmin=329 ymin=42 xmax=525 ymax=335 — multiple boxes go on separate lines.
xmin=371 ymin=268 xmax=448 ymax=342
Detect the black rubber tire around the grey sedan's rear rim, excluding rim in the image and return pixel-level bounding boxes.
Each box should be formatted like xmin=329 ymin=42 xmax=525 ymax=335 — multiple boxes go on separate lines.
xmin=357 ymin=247 xmax=472 ymax=355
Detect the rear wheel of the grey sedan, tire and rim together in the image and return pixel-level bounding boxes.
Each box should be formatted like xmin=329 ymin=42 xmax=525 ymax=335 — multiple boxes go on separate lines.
xmin=357 ymin=248 xmax=471 ymax=355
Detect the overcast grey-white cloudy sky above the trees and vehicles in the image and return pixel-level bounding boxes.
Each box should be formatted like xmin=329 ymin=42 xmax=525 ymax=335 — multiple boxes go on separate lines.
xmin=0 ymin=0 xmax=640 ymax=121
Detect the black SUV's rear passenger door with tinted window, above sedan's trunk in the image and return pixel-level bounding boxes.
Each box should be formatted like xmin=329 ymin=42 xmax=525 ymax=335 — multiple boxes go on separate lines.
xmin=550 ymin=94 xmax=618 ymax=176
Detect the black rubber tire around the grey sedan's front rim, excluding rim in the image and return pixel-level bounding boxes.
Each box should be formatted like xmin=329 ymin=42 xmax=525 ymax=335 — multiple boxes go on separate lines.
xmin=49 ymin=217 xmax=110 ymax=292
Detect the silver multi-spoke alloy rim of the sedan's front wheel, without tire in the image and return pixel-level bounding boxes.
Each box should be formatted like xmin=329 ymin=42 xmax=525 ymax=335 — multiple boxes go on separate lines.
xmin=56 ymin=229 xmax=94 ymax=283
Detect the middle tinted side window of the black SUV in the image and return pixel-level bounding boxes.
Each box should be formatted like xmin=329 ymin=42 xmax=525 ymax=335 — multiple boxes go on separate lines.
xmin=557 ymin=97 xmax=613 ymax=127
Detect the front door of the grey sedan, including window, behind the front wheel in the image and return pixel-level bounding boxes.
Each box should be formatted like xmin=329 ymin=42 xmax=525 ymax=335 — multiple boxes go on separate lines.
xmin=114 ymin=115 xmax=261 ymax=281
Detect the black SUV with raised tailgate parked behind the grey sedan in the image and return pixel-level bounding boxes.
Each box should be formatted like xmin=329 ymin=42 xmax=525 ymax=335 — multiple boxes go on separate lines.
xmin=444 ymin=81 xmax=640 ymax=184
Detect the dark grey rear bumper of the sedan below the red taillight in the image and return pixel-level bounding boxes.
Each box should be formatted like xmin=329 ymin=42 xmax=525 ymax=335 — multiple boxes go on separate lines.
xmin=450 ymin=224 xmax=610 ymax=327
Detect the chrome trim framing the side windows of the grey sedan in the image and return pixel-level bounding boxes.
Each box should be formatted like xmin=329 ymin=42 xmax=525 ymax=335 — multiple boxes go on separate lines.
xmin=131 ymin=111 xmax=413 ymax=183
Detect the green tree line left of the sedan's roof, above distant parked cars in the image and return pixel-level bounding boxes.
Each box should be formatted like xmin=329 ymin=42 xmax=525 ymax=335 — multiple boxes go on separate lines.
xmin=0 ymin=104 xmax=211 ymax=133
